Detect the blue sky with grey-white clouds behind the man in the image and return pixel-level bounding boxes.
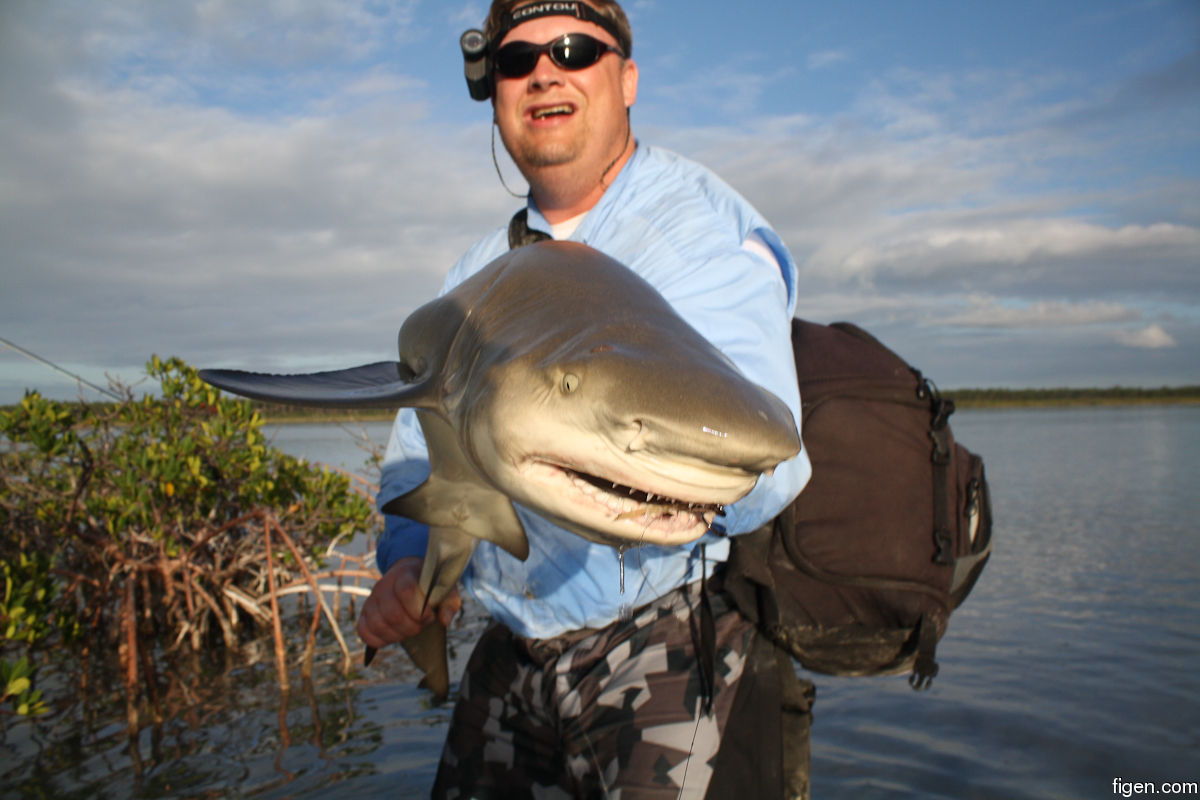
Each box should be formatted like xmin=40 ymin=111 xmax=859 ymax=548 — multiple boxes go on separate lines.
xmin=0 ymin=0 xmax=1200 ymax=404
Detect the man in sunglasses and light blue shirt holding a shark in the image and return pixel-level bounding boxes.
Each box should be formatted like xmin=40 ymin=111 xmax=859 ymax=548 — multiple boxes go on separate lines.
xmin=359 ymin=0 xmax=809 ymax=798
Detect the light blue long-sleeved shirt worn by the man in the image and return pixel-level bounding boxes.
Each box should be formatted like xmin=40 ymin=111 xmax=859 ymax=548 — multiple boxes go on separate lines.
xmin=376 ymin=145 xmax=811 ymax=638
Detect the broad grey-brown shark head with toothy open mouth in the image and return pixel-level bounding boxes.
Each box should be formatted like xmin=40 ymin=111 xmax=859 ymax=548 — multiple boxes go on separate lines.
xmin=427 ymin=242 xmax=800 ymax=546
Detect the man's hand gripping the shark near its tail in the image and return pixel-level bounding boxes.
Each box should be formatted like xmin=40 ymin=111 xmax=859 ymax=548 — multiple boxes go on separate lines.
xmin=358 ymin=557 xmax=462 ymax=648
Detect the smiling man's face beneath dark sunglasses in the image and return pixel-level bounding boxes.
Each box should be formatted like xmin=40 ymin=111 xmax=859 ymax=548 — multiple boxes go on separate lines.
xmin=494 ymin=10 xmax=637 ymax=178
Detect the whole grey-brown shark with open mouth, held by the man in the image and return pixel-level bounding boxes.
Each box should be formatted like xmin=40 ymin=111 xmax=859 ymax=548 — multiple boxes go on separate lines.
xmin=199 ymin=241 xmax=802 ymax=699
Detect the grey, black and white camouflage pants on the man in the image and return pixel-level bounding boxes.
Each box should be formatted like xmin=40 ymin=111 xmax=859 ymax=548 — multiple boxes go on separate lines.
xmin=433 ymin=584 xmax=768 ymax=800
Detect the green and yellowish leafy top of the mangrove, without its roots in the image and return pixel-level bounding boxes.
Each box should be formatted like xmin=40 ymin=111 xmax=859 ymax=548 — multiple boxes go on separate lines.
xmin=0 ymin=356 xmax=371 ymax=547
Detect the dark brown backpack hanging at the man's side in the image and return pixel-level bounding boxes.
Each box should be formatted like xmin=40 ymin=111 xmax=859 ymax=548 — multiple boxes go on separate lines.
xmin=725 ymin=319 xmax=991 ymax=688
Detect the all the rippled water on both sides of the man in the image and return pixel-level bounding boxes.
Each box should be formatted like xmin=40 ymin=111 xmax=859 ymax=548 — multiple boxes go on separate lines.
xmin=0 ymin=407 xmax=1200 ymax=799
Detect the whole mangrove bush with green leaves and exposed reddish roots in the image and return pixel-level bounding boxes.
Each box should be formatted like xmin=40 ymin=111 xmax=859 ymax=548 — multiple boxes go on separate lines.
xmin=0 ymin=356 xmax=376 ymax=714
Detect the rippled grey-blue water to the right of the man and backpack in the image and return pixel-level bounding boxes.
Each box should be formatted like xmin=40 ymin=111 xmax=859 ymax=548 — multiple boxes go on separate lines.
xmin=812 ymin=408 xmax=1200 ymax=798
